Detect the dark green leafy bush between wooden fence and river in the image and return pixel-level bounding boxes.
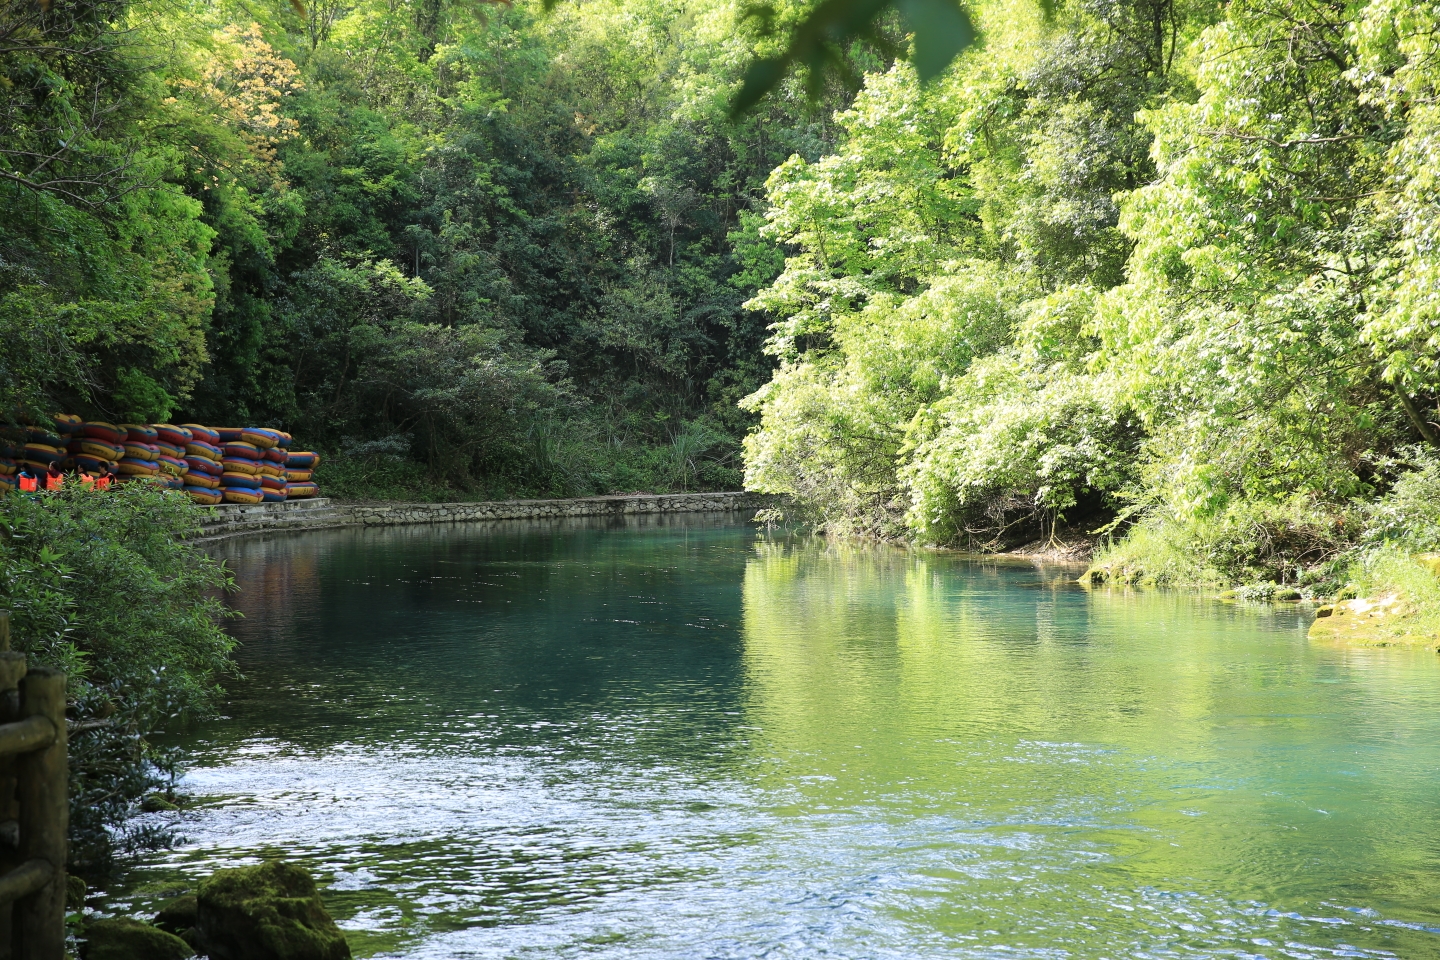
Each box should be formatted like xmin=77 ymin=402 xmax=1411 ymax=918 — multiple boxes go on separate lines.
xmin=0 ymin=484 xmax=233 ymax=872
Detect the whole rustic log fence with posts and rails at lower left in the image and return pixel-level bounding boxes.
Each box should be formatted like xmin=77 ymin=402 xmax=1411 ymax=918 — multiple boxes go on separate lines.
xmin=0 ymin=610 xmax=71 ymax=960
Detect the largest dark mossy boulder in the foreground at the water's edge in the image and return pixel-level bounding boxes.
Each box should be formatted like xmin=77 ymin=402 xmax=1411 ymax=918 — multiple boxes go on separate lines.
xmin=196 ymin=861 xmax=350 ymax=960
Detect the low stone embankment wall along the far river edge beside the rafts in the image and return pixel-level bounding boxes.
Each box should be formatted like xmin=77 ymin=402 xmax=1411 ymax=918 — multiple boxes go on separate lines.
xmin=196 ymin=491 xmax=773 ymax=543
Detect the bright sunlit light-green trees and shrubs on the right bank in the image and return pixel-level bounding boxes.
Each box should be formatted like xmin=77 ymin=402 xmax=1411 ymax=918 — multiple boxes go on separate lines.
xmin=744 ymin=0 xmax=1440 ymax=593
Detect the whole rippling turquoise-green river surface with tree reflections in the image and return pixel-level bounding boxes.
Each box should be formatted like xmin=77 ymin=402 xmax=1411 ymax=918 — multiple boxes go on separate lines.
xmin=101 ymin=517 xmax=1440 ymax=959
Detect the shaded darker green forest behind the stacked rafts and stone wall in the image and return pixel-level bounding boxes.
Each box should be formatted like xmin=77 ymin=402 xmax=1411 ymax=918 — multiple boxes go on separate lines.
xmin=0 ymin=0 xmax=838 ymax=497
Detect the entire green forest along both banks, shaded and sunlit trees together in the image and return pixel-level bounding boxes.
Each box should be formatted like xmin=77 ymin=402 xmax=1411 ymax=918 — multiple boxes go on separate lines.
xmin=8 ymin=0 xmax=1440 ymax=583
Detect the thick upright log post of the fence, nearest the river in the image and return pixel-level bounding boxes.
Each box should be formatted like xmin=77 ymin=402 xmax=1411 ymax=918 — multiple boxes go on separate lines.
xmin=12 ymin=666 xmax=71 ymax=960
